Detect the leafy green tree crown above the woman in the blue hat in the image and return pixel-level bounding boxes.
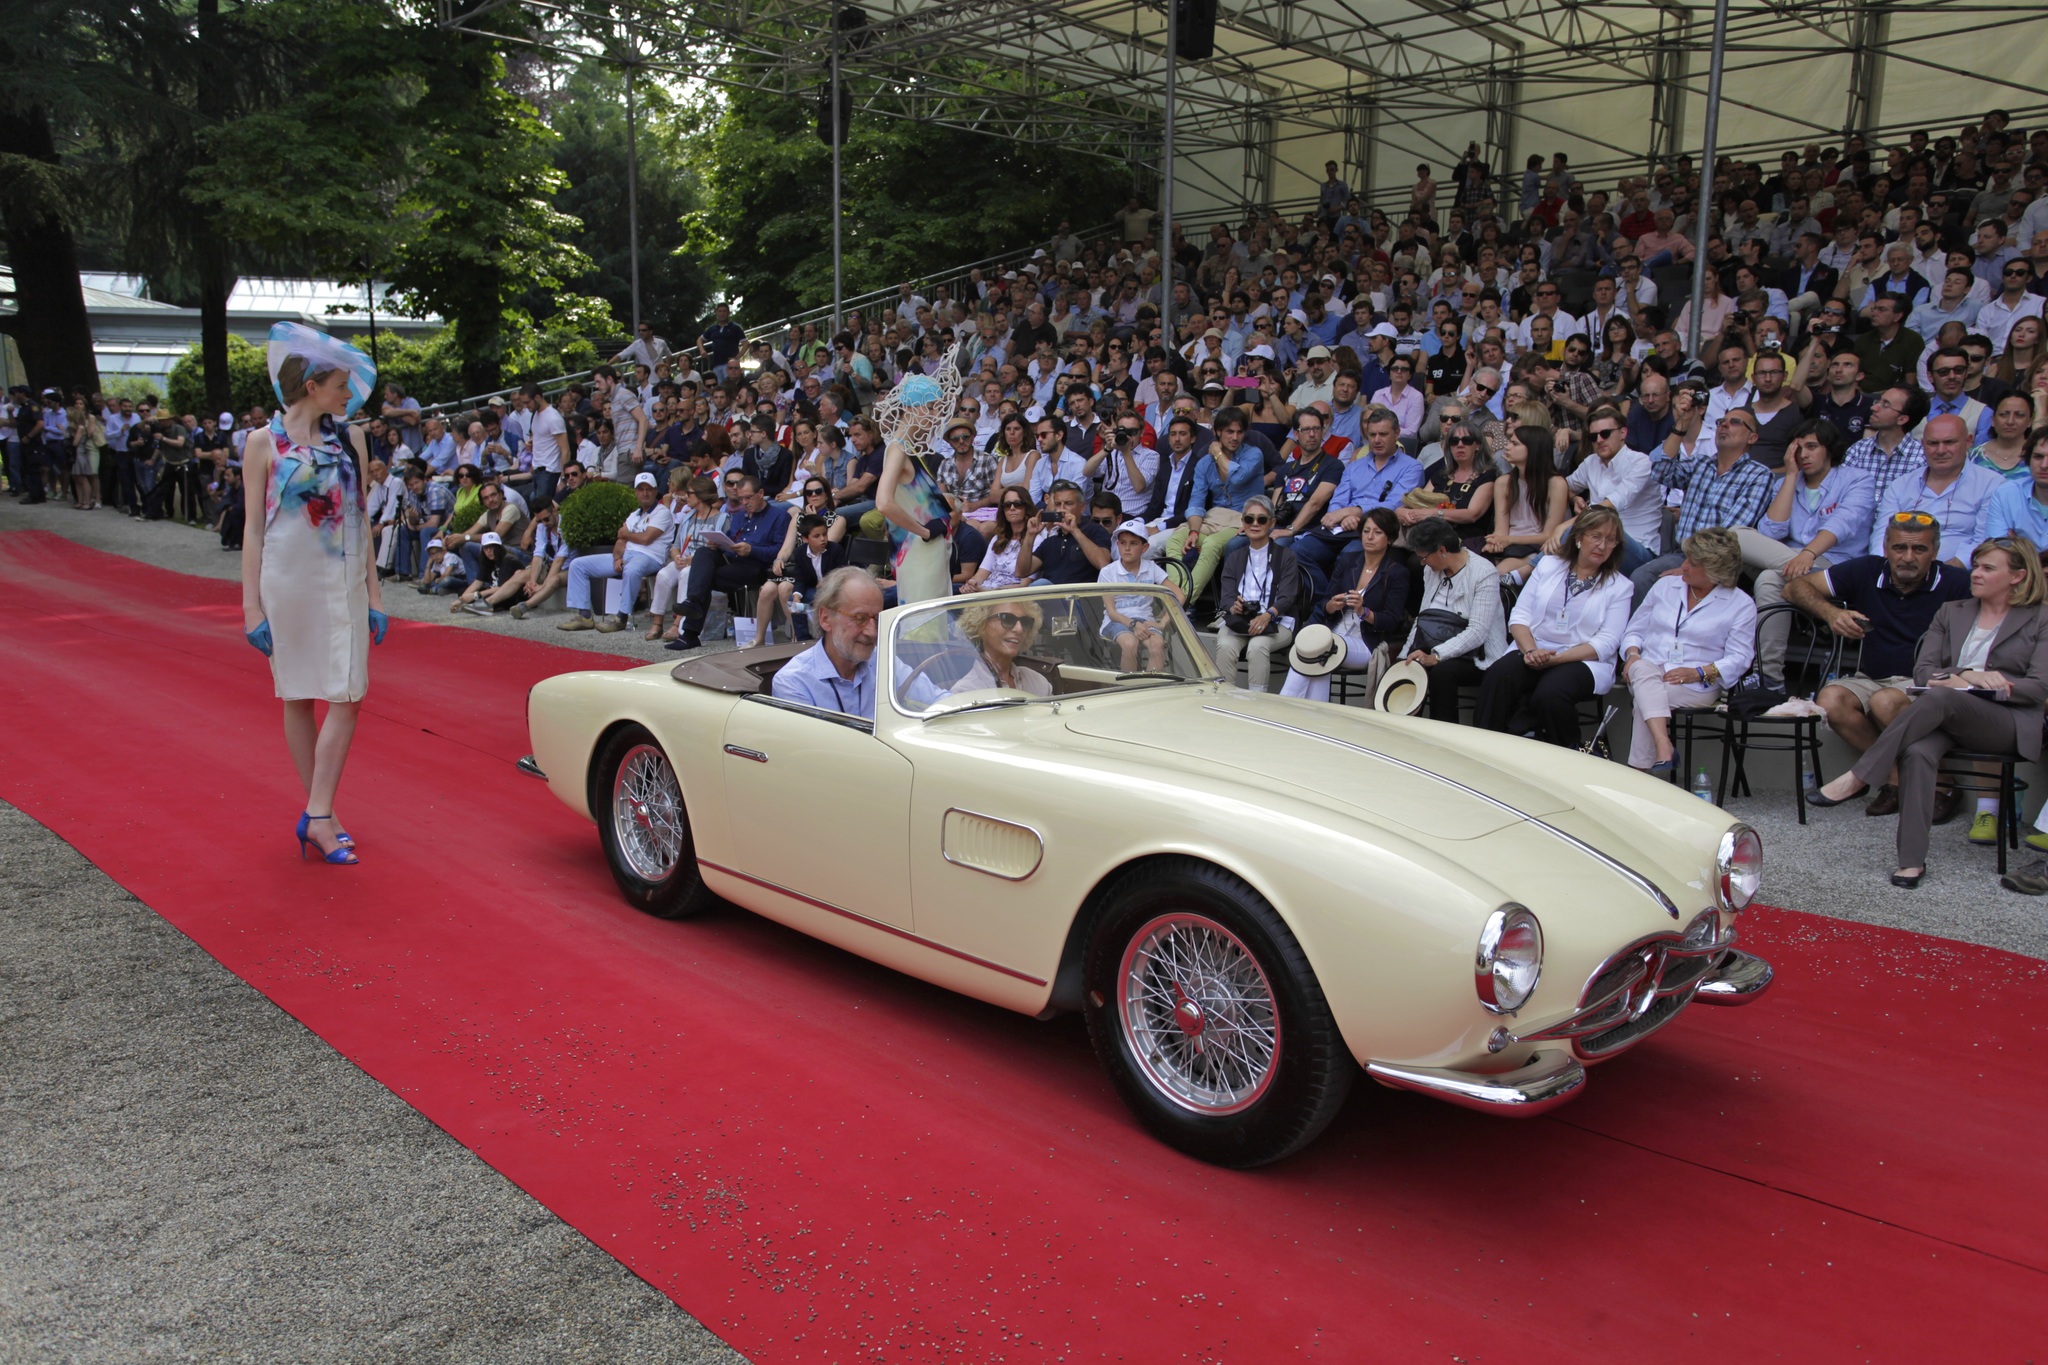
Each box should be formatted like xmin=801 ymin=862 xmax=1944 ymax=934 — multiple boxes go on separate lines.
xmin=195 ymin=0 xmax=590 ymax=393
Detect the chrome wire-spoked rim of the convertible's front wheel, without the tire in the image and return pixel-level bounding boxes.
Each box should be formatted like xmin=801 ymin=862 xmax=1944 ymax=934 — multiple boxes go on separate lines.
xmin=1116 ymin=915 xmax=1280 ymax=1115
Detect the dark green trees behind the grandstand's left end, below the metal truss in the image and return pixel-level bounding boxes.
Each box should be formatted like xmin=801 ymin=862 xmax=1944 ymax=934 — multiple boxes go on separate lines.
xmin=698 ymin=83 xmax=1130 ymax=321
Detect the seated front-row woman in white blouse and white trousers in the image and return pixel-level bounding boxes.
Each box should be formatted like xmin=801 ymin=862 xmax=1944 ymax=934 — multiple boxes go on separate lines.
xmin=1622 ymin=526 xmax=1757 ymax=778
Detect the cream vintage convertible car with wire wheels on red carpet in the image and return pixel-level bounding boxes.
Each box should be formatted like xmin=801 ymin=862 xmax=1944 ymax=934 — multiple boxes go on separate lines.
xmin=522 ymin=585 xmax=1772 ymax=1166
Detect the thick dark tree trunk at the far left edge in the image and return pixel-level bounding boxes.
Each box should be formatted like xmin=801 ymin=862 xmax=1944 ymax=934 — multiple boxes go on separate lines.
xmin=0 ymin=106 xmax=100 ymax=393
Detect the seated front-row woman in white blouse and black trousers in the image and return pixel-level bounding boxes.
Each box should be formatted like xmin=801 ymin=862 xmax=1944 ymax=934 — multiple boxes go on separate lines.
xmin=1475 ymin=508 xmax=1632 ymax=749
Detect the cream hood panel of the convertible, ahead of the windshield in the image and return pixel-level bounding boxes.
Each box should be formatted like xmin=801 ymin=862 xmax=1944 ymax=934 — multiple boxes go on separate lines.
xmin=1067 ymin=688 xmax=1571 ymax=841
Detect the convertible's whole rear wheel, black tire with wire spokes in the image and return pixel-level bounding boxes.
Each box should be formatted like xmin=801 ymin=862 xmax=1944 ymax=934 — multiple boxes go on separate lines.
xmin=590 ymin=724 xmax=719 ymax=919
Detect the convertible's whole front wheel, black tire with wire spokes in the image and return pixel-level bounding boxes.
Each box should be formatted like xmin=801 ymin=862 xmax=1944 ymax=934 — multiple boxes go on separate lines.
xmin=1083 ymin=860 xmax=1358 ymax=1169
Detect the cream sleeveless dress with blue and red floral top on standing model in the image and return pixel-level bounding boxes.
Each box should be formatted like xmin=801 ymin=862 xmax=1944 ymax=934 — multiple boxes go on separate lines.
xmin=258 ymin=417 xmax=371 ymax=702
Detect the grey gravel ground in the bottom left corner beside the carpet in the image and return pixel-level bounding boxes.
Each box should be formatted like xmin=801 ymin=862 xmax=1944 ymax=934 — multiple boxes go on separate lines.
xmin=0 ymin=802 xmax=741 ymax=1365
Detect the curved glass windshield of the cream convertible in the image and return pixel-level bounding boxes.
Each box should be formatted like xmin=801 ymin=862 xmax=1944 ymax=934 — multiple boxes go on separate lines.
xmin=889 ymin=583 xmax=1217 ymax=714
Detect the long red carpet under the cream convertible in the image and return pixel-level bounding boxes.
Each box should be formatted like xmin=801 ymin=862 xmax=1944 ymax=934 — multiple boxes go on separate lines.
xmin=0 ymin=534 xmax=2048 ymax=1365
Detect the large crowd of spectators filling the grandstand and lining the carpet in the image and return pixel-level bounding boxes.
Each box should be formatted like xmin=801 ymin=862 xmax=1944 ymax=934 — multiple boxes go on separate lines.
xmin=12 ymin=111 xmax=2048 ymax=892
